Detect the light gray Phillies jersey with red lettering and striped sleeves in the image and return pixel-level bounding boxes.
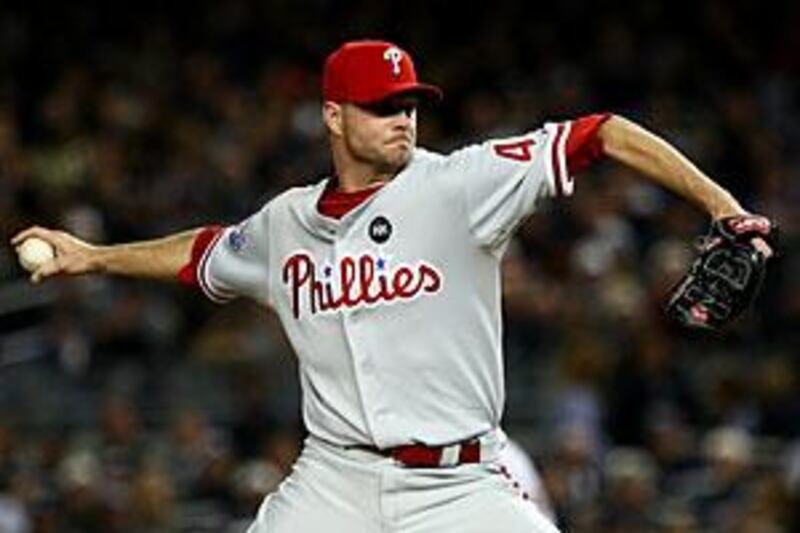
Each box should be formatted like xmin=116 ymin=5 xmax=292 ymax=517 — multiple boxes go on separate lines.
xmin=196 ymin=122 xmax=573 ymax=448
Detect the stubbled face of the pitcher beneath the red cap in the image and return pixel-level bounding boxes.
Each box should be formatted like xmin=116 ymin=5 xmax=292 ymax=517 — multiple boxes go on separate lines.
xmin=332 ymin=95 xmax=417 ymax=173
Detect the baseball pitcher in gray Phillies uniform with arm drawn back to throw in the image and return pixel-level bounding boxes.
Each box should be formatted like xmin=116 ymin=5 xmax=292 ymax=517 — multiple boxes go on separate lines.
xmin=12 ymin=41 xmax=771 ymax=533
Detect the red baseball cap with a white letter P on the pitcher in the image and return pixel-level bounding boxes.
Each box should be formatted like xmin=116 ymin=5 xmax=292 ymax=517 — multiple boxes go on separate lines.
xmin=322 ymin=41 xmax=442 ymax=104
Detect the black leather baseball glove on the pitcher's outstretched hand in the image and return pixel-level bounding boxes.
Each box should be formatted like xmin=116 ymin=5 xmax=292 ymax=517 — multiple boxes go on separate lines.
xmin=667 ymin=215 xmax=775 ymax=330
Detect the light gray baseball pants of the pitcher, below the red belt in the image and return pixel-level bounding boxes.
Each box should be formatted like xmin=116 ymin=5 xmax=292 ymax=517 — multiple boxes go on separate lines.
xmin=248 ymin=437 xmax=558 ymax=533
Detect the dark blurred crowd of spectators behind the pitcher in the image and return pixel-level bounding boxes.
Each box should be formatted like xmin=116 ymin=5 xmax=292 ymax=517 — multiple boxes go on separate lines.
xmin=0 ymin=0 xmax=800 ymax=533
